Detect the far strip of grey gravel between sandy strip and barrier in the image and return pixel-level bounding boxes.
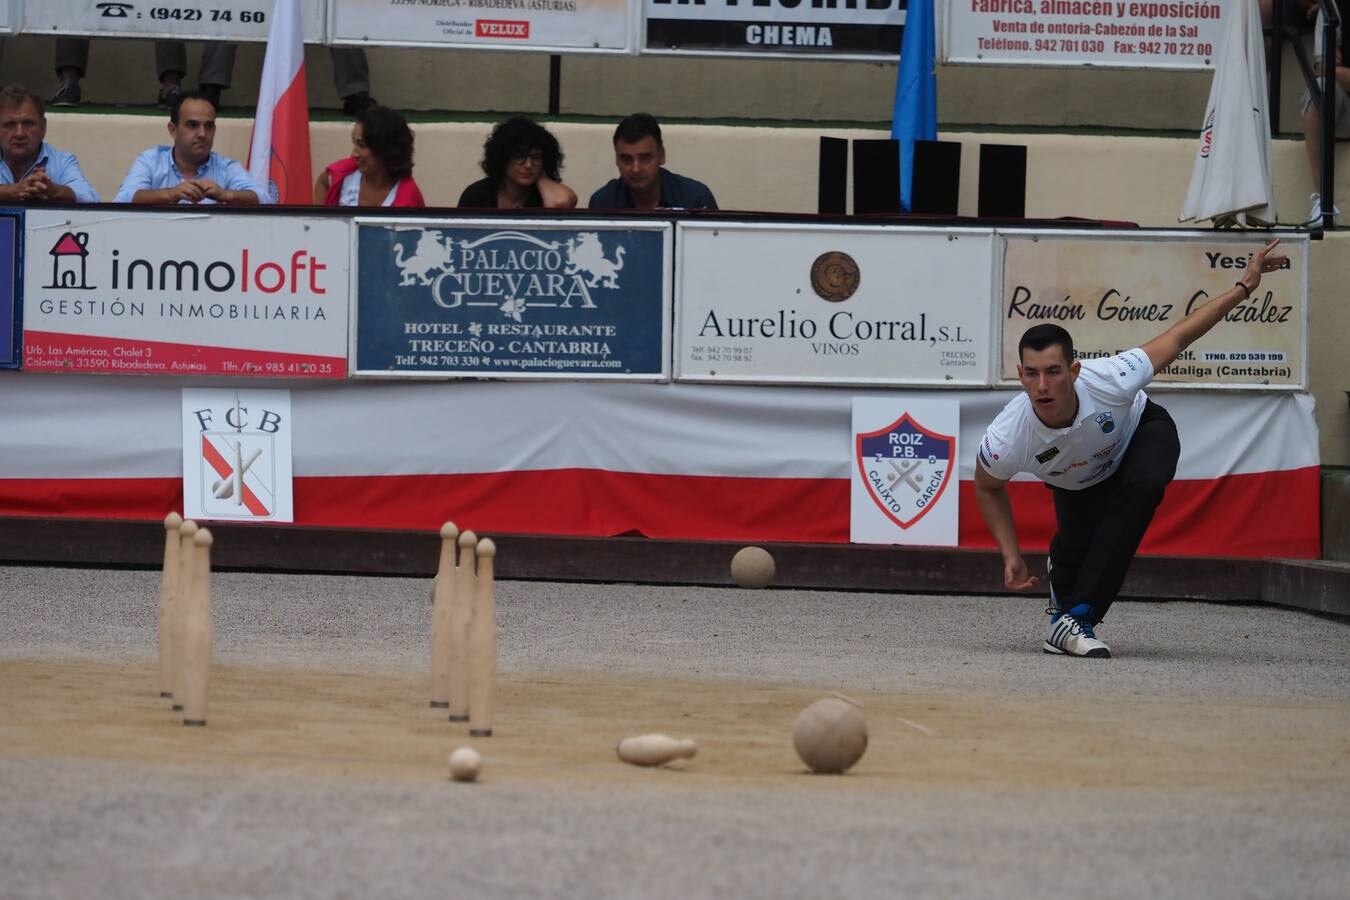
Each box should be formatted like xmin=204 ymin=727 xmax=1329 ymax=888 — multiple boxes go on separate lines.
xmin=0 ymin=567 xmax=1350 ymax=700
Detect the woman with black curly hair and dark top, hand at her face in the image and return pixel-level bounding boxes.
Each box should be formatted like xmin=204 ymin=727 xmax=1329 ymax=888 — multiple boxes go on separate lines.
xmin=458 ymin=116 xmax=576 ymax=209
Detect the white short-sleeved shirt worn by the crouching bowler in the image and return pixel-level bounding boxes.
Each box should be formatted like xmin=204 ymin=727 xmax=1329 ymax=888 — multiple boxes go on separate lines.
xmin=979 ymin=348 xmax=1153 ymax=491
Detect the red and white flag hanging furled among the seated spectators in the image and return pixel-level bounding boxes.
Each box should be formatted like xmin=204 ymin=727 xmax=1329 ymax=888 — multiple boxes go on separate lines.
xmin=248 ymin=0 xmax=315 ymax=205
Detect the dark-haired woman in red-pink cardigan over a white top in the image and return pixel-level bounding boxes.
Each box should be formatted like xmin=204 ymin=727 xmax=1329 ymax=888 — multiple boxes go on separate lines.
xmin=315 ymin=107 xmax=427 ymax=206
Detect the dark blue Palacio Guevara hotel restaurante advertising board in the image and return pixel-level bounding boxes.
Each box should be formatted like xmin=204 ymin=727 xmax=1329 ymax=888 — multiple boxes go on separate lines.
xmin=352 ymin=219 xmax=671 ymax=381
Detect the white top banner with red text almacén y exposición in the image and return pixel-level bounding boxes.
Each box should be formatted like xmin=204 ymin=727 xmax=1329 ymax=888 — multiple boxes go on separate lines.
xmin=945 ymin=0 xmax=1234 ymax=69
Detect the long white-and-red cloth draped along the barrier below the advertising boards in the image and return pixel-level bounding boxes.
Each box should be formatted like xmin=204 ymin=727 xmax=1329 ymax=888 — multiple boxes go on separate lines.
xmin=0 ymin=372 xmax=1320 ymax=559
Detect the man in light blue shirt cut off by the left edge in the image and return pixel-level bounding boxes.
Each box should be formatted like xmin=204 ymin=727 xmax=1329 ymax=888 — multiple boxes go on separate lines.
xmin=0 ymin=85 xmax=99 ymax=204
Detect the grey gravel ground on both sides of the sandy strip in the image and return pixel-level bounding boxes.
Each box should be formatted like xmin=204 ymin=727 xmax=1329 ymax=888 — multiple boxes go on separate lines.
xmin=0 ymin=567 xmax=1350 ymax=900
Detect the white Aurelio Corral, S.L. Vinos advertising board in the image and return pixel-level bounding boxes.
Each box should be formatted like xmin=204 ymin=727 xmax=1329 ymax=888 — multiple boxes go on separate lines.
xmin=675 ymin=223 xmax=994 ymax=385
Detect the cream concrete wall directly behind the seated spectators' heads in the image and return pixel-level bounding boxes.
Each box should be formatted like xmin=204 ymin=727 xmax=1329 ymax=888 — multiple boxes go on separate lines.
xmin=47 ymin=111 xmax=1350 ymax=227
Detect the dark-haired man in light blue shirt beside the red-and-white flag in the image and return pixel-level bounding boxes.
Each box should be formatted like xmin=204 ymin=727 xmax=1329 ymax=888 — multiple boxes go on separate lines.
xmin=115 ymin=90 xmax=269 ymax=206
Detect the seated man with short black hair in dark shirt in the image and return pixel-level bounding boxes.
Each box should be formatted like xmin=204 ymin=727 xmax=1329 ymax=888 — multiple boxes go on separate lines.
xmin=587 ymin=112 xmax=717 ymax=209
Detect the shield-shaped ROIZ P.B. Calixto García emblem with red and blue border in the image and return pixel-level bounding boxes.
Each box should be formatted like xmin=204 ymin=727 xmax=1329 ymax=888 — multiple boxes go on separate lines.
xmin=855 ymin=413 xmax=956 ymax=528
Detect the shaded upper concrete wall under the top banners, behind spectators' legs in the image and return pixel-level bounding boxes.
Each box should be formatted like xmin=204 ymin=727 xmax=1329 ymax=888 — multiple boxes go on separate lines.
xmin=0 ymin=35 xmax=1328 ymax=132
